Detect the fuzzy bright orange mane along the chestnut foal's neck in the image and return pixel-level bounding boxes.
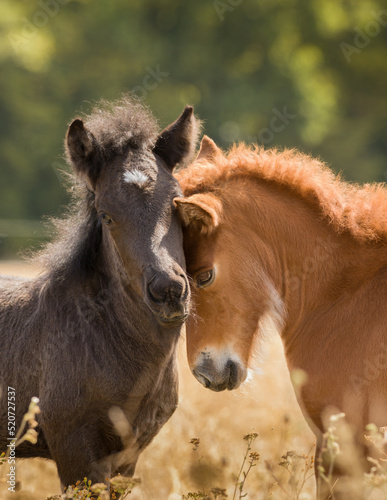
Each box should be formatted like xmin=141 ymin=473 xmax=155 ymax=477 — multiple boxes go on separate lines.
xmin=178 ymin=144 xmax=387 ymax=242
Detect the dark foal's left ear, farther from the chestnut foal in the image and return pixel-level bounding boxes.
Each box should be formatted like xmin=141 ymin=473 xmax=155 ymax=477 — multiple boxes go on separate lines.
xmin=65 ymin=118 xmax=97 ymax=187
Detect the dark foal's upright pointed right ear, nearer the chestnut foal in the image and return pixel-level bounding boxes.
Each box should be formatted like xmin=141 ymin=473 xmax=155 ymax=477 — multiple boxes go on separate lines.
xmin=153 ymin=106 xmax=200 ymax=170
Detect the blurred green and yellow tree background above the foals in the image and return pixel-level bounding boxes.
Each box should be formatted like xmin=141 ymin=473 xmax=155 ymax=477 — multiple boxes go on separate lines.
xmin=0 ymin=0 xmax=387 ymax=258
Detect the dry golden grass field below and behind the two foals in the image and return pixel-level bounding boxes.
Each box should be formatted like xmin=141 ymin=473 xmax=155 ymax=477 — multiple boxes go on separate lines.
xmin=0 ymin=262 xmax=315 ymax=500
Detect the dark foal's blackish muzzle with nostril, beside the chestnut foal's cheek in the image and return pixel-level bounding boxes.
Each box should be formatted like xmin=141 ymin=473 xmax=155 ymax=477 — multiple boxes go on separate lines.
xmin=147 ymin=272 xmax=189 ymax=325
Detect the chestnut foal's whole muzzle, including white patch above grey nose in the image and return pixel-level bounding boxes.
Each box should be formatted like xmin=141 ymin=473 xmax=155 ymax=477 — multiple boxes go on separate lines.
xmin=191 ymin=349 xmax=247 ymax=392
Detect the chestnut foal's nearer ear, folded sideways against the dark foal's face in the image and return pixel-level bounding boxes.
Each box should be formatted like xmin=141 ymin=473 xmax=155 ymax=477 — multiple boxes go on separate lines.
xmin=173 ymin=193 xmax=222 ymax=233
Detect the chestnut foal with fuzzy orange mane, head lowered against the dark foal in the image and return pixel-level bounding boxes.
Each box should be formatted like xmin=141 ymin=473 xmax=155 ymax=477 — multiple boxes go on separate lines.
xmin=174 ymin=137 xmax=387 ymax=498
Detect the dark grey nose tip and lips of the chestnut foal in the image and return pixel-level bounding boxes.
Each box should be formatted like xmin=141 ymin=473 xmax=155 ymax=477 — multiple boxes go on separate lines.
xmin=192 ymin=356 xmax=246 ymax=392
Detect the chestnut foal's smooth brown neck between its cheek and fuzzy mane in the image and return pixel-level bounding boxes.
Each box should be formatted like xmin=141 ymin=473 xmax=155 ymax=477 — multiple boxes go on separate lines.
xmin=230 ymin=181 xmax=387 ymax=336
